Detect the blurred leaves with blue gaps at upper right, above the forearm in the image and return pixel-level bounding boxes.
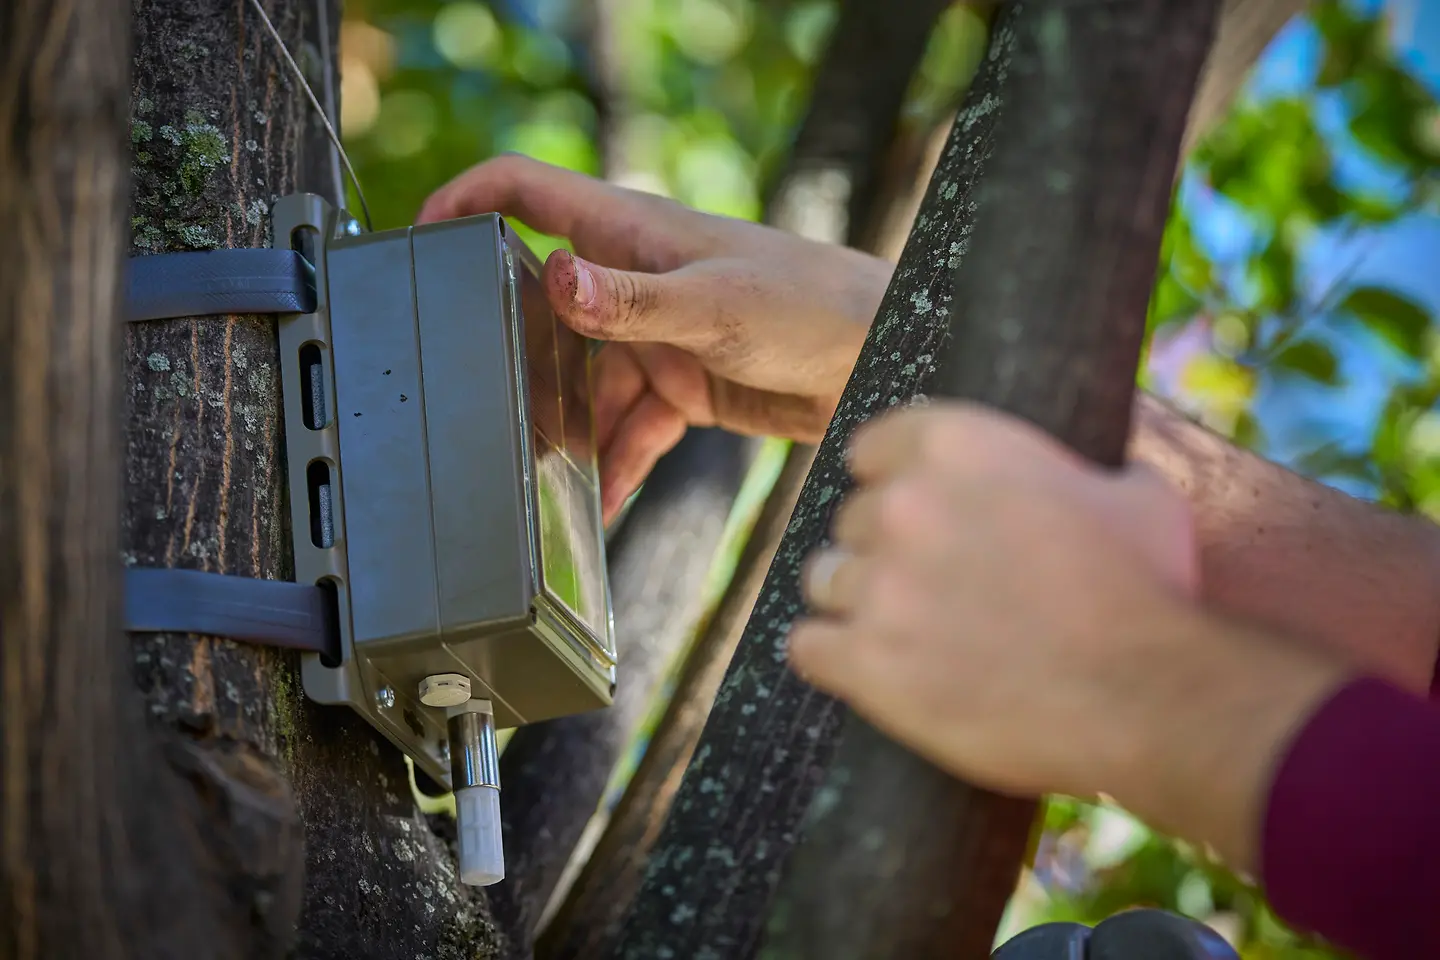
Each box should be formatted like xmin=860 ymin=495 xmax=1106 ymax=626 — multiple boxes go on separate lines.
xmin=1151 ymin=0 xmax=1440 ymax=514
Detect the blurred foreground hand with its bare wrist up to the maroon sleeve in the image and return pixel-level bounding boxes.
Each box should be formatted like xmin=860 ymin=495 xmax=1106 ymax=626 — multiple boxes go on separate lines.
xmin=789 ymin=403 xmax=1348 ymax=868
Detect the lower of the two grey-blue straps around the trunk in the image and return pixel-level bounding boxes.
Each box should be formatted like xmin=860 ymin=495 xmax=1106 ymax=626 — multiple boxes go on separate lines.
xmin=124 ymin=567 xmax=340 ymax=656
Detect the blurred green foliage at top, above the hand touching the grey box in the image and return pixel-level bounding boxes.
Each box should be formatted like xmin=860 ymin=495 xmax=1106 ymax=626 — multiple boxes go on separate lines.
xmin=341 ymin=0 xmax=984 ymax=256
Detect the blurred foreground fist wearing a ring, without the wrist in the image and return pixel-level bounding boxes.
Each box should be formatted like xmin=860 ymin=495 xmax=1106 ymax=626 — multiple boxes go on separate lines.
xmin=791 ymin=403 xmax=1198 ymax=794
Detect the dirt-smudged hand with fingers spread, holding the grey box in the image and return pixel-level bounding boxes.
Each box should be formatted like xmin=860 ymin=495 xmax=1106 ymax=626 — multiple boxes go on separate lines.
xmin=416 ymin=155 xmax=893 ymax=520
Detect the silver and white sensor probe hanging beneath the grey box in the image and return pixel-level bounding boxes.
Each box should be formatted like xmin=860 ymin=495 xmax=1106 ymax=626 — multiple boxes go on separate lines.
xmin=446 ymin=699 xmax=505 ymax=887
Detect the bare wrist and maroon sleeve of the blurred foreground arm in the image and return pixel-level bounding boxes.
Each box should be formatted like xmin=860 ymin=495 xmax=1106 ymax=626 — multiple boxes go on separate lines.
xmin=1107 ymin=609 xmax=1440 ymax=960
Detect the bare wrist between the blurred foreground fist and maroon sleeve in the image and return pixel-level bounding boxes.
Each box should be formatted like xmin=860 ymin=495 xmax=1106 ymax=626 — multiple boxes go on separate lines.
xmin=1115 ymin=609 xmax=1352 ymax=872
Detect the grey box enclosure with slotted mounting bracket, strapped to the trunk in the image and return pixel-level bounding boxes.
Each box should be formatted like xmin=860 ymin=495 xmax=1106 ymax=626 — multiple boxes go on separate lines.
xmin=272 ymin=194 xmax=616 ymax=787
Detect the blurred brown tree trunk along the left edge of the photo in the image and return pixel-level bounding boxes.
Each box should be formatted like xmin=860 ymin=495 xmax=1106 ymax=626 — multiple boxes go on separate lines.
xmin=0 ymin=0 xmax=301 ymax=960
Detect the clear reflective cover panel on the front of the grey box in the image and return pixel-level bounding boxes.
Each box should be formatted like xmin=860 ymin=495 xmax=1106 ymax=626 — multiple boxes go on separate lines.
xmin=516 ymin=250 xmax=611 ymax=649
